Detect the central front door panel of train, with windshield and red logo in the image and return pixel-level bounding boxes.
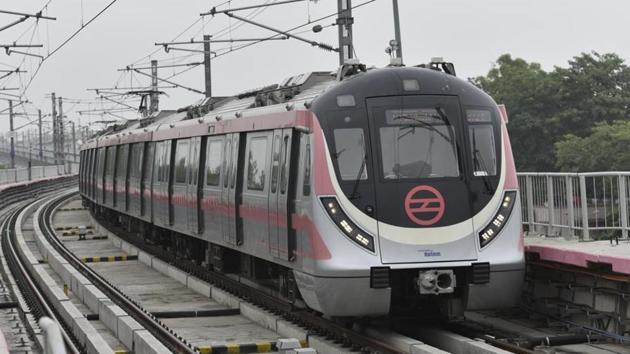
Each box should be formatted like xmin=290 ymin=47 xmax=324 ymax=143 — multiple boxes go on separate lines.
xmin=362 ymin=95 xmax=477 ymax=263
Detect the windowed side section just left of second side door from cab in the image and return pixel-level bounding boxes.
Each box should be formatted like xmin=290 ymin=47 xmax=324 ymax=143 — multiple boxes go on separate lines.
xmin=201 ymin=136 xmax=226 ymax=240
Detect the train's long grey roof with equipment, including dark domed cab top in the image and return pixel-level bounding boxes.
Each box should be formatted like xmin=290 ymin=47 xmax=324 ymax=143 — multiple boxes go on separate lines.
xmin=83 ymin=63 xmax=491 ymax=148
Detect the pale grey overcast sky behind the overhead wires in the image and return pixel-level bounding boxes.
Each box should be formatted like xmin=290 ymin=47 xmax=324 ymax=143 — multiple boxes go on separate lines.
xmin=0 ymin=0 xmax=630 ymax=141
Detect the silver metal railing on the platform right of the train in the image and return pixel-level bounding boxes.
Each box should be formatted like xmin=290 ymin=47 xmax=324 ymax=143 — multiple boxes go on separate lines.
xmin=518 ymin=172 xmax=630 ymax=241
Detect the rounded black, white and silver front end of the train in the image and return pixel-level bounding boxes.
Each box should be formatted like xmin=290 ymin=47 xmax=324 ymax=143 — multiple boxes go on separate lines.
xmin=295 ymin=68 xmax=524 ymax=317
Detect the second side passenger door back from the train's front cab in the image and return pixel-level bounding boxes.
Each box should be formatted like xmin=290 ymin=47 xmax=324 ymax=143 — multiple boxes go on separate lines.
xmin=221 ymin=133 xmax=243 ymax=245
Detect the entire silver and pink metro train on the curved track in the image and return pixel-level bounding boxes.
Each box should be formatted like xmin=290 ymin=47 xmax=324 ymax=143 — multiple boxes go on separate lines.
xmin=80 ymin=63 xmax=524 ymax=318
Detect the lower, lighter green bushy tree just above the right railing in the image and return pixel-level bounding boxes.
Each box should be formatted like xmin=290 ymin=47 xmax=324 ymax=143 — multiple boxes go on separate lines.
xmin=556 ymin=120 xmax=630 ymax=172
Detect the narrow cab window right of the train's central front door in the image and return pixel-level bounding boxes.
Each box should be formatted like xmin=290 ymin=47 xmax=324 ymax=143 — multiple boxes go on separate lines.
xmin=468 ymin=124 xmax=497 ymax=176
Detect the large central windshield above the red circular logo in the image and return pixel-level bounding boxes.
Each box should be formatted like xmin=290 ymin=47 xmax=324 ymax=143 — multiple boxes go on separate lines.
xmin=378 ymin=106 xmax=459 ymax=180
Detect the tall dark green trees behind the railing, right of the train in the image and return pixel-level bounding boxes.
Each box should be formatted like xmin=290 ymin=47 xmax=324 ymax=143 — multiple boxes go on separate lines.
xmin=471 ymin=52 xmax=630 ymax=171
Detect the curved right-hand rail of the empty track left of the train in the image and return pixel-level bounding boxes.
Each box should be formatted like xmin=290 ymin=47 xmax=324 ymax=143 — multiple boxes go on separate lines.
xmin=37 ymin=192 xmax=197 ymax=354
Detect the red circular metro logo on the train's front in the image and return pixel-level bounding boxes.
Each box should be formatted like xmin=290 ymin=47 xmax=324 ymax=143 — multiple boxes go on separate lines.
xmin=405 ymin=185 xmax=445 ymax=226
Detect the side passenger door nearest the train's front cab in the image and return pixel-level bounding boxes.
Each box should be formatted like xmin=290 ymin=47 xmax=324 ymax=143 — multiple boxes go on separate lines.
xmin=269 ymin=129 xmax=298 ymax=260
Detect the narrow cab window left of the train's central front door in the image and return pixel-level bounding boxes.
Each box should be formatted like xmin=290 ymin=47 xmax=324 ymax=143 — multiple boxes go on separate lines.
xmin=333 ymin=128 xmax=368 ymax=181
